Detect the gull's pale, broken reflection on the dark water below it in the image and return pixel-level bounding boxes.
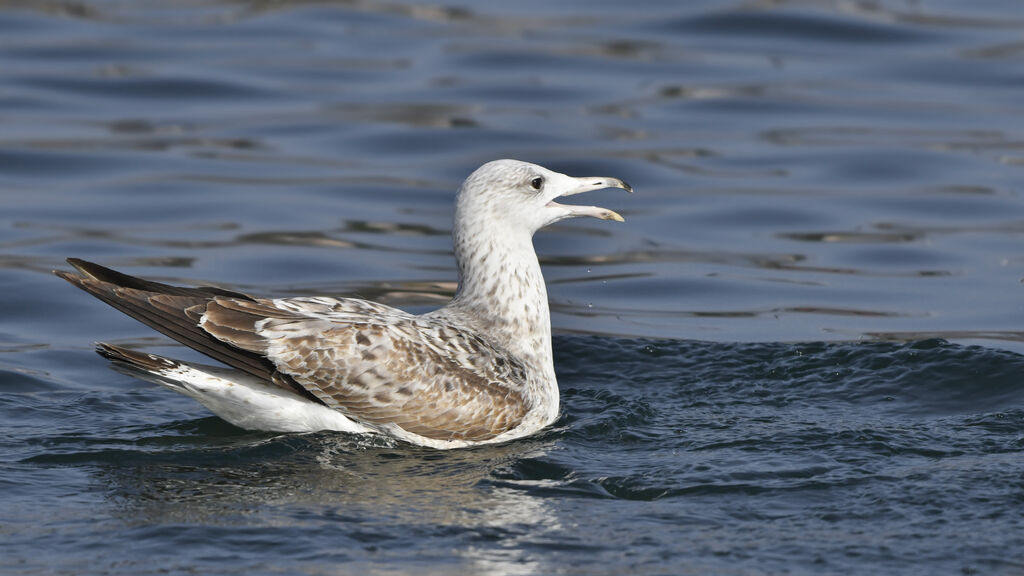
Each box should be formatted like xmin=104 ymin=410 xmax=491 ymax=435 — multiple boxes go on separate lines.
xmin=101 ymin=426 xmax=559 ymax=575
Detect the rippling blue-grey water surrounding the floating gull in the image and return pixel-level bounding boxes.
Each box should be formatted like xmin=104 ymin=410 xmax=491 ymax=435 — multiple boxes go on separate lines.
xmin=0 ymin=0 xmax=1024 ymax=575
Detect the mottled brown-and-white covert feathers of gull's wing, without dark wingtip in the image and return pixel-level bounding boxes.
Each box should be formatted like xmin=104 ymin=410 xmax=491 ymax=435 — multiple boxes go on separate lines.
xmin=202 ymin=298 xmax=530 ymax=441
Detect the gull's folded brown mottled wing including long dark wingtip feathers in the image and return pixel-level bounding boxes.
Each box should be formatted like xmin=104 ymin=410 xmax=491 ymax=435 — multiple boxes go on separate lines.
xmin=57 ymin=259 xmax=530 ymax=441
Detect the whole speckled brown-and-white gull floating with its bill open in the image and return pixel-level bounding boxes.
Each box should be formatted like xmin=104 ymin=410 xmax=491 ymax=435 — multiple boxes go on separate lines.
xmin=54 ymin=160 xmax=633 ymax=449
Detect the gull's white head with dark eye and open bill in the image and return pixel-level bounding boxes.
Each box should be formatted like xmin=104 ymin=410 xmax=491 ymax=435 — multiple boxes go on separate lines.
xmin=456 ymin=160 xmax=633 ymax=236
